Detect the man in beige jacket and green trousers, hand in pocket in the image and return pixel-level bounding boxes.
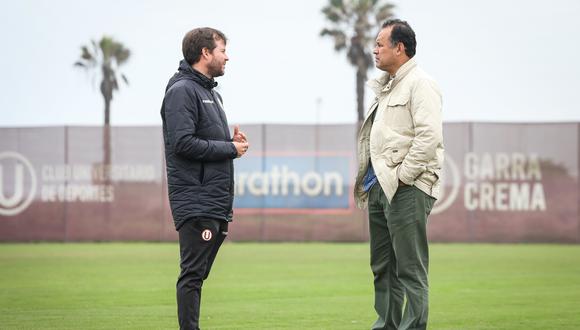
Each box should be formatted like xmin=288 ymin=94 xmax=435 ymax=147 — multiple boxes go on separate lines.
xmin=354 ymin=20 xmax=443 ymax=329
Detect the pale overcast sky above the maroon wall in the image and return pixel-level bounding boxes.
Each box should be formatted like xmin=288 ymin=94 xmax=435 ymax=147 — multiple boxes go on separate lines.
xmin=0 ymin=0 xmax=580 ymax=127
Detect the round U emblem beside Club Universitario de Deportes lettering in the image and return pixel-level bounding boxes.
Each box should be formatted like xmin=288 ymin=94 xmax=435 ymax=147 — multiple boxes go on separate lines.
xmin=0 ymin=151 xmax=36 ymax=216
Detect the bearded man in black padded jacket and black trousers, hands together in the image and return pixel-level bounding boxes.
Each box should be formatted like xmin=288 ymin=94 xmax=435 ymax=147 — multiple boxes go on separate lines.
xmin=161 ymin=28 xmax=248 ymax=329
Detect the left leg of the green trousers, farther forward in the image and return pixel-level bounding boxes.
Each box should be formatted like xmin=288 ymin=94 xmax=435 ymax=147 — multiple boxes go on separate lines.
xmin=368 ymin=183 xmax=404 ymax=330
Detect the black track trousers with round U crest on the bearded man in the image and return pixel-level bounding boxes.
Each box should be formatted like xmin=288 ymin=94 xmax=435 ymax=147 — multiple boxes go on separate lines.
xmin=176 ymin=219 xmax=223 ymax=330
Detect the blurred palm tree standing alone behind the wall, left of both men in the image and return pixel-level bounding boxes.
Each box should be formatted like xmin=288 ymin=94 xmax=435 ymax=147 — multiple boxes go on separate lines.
xmin=74 ymin=36 xmax=131 ymax=165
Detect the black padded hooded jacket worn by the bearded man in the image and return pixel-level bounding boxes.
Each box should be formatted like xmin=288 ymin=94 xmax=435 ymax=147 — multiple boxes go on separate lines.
xmin=161 ymin=60 xmax=237 ymax=229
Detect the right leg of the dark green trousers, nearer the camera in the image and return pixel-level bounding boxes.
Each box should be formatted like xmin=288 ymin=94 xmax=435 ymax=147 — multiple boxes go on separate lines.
xmin=387 ymin=186 xmax=435 ymax=330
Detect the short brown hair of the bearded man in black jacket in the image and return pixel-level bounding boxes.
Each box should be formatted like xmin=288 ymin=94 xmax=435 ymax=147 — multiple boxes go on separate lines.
xmin=181 ymin=27 xmax=227 ymax=65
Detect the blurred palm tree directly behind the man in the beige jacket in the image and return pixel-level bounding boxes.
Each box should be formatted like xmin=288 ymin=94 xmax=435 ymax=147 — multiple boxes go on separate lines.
xmin=320 ymin=0 xmax=395 ymax=123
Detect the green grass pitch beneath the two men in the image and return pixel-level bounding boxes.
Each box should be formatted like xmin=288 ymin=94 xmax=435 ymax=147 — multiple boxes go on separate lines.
xmin=0 ymin=243 xmax=580 ymax=330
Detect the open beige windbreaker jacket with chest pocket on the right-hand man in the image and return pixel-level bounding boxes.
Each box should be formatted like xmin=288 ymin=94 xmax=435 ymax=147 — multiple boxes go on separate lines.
xmin=354 ymin=59 xmax=444 ymax=208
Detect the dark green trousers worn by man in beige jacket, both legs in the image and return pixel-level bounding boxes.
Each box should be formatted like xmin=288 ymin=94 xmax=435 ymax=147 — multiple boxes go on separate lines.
xmin=368 ymin=183 xmax=435 ymax=330
